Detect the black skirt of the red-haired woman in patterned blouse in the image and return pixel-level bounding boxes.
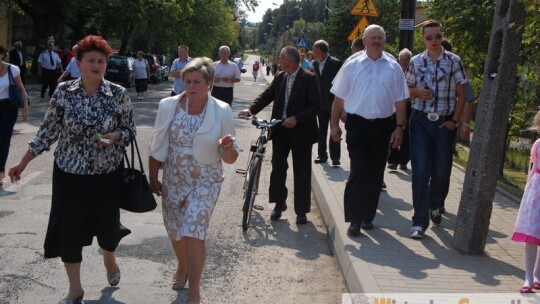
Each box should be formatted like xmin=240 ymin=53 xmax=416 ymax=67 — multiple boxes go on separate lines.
xmin=44 ymin=162 xmax=130 ymax=263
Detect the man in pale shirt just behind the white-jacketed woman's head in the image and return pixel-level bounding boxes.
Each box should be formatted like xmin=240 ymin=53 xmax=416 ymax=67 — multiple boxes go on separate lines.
xmin=212 ymin=45 xmax=240 ymax=105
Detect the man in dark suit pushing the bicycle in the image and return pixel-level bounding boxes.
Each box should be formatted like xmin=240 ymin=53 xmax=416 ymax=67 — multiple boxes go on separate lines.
xmin=238 ymin=46 xmax=320 ymax=224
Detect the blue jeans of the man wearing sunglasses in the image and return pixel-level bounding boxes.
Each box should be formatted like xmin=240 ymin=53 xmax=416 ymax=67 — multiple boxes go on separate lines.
xmin=409 ymin=110 xmax=454 ymax=230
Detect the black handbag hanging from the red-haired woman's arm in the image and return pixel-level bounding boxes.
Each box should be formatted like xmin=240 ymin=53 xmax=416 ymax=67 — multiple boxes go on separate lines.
xmin=119 ymin=132 xmax=157 ymax=213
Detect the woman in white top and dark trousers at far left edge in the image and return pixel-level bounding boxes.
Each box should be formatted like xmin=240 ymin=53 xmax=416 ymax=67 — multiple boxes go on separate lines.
xmin=0 ymin=45 xmax=28 ymax=187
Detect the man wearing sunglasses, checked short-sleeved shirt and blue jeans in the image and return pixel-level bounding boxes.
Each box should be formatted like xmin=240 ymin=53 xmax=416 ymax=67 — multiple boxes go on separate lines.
xmin=405 ymin=20 xmax=467 ymax=239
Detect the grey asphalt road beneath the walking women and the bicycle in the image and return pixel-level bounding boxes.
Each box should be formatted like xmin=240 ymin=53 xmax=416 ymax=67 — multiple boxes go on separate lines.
xmin=0 ymin=70 xmax=345 ymax=304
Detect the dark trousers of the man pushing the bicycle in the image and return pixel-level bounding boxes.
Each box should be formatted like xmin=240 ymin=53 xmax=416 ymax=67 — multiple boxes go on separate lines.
xmin=269 ymin=127 xmax=313 ymax=214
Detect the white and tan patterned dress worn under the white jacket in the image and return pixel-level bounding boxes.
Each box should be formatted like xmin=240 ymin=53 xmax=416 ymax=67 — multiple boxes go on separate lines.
xmin=163 ymin=106 xmax=223 ymax=241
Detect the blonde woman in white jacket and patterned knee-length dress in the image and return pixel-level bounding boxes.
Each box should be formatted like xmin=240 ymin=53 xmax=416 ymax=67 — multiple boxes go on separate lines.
xmin=149 ymin=58 xmax=239 ymax=303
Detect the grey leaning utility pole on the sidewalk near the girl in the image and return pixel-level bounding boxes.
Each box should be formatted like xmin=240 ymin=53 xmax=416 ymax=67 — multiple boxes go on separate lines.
xmin=453 ymin=0 xmax=526 ymax=254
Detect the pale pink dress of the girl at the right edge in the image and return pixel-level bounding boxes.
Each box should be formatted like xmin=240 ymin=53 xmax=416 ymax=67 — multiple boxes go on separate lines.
xmin=512 ymin=139 xmax=540 ymax=246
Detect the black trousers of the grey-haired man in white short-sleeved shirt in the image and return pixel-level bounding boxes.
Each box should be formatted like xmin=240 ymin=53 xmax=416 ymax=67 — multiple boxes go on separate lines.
xmin=344 ymin=114 xmax=395 ymax=222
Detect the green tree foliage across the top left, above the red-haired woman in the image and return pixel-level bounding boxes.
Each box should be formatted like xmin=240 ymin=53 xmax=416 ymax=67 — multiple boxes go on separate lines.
xmin=8 ymin=0 xmax=243 ymax=56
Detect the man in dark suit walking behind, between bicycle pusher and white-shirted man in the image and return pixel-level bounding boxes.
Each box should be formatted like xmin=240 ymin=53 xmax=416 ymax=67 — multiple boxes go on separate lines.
xmin=312 ymin=40 xmax=341 ymax=166
